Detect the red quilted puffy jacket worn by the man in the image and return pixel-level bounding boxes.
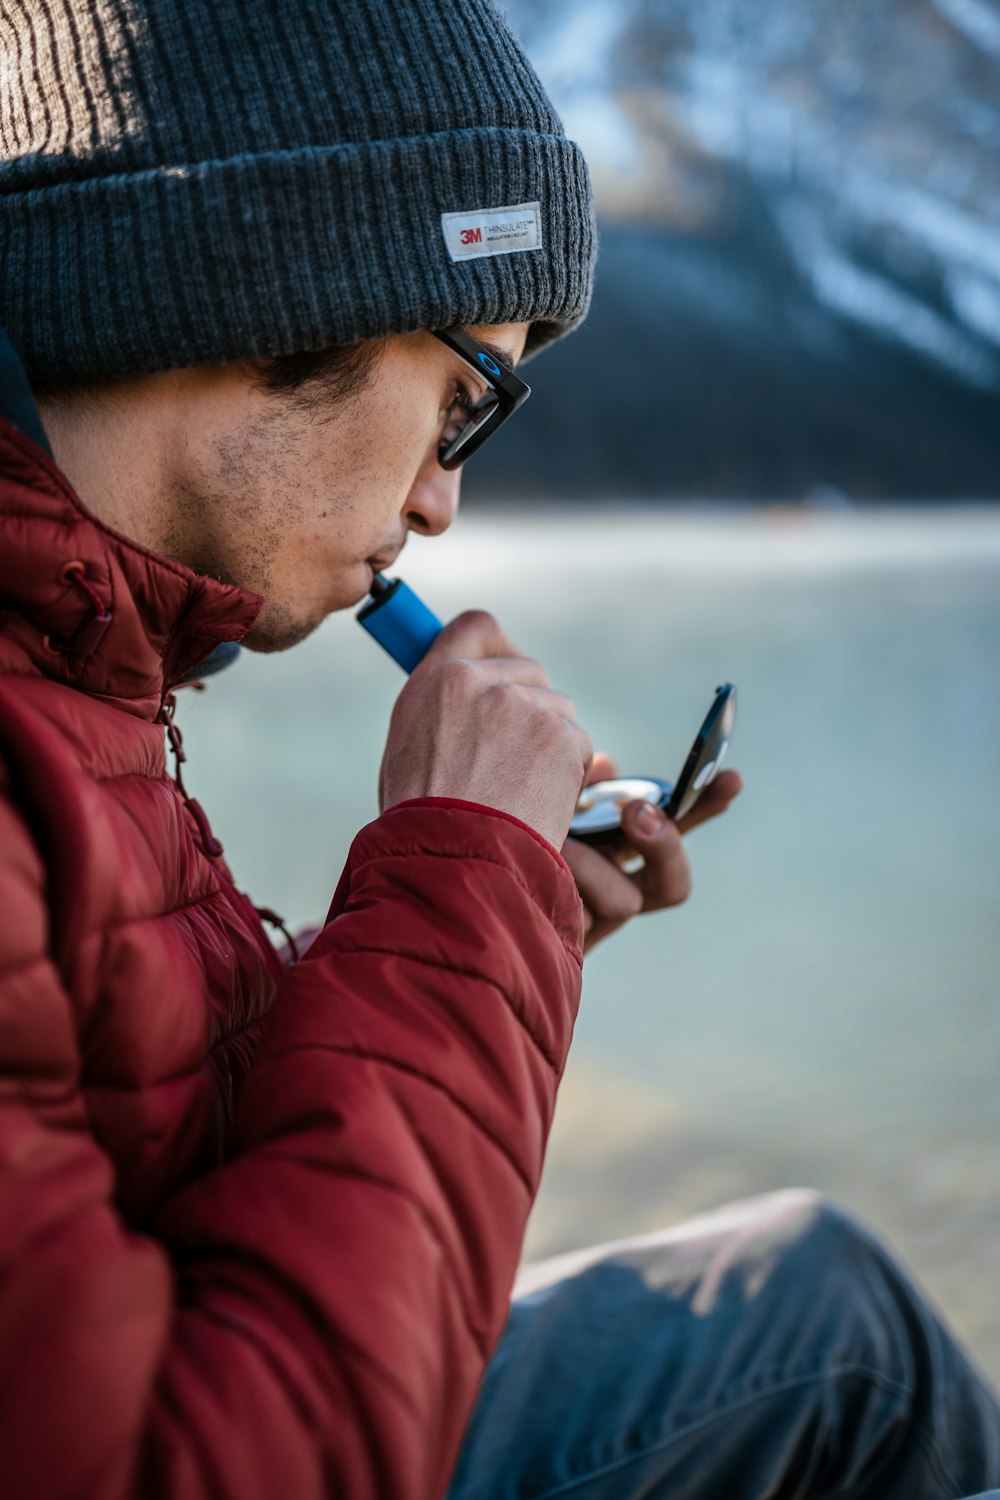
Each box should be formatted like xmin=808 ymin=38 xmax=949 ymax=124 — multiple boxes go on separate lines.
xmin=0 ymin=419 xmax=582 ymax=1500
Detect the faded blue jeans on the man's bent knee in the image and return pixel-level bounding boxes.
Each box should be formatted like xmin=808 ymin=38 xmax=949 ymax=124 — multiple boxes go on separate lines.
xmin=447 ymin=1191 xmax=1000 ymax=1500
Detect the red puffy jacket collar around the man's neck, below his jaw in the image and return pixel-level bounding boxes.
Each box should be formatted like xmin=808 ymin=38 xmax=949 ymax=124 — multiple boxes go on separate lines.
xmin=0 ymin=416 xmax=264 ymax=719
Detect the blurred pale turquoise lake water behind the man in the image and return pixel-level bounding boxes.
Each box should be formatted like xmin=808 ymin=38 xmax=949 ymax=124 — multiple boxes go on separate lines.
xmin=180 ymin=509 xmax=1000 ymax=1376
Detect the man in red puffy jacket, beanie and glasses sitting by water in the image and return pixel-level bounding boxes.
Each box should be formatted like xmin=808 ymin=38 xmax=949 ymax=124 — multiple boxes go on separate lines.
xmin=0 ymin=0 xmax=1000 ymax=1500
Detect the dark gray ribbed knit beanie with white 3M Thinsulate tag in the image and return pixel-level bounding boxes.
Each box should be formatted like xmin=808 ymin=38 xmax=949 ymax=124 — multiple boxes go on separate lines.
xmin=0 ymin=0 xmax=595 ymax=381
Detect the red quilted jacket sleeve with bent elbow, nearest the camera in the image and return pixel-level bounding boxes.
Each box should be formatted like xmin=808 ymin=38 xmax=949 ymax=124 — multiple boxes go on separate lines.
xmin=0 ymin=801 xmax=582 ymax=1500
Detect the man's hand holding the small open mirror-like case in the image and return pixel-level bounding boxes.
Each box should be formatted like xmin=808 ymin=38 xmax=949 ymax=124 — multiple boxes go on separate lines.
xmin=562 ymin=755 xmax=744 ymax=953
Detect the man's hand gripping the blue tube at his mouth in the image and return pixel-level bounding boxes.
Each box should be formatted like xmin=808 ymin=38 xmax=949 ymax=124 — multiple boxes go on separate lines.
xmin=379 ymin=611 xmax=594 ymax=849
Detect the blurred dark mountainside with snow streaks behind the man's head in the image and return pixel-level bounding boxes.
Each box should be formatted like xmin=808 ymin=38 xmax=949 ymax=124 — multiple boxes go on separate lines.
xmin=469 ymin=0 xmax=1000 ymax=498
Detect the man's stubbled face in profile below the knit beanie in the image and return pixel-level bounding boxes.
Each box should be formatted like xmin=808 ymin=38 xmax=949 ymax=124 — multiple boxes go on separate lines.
xmin=160 ymin=323 xmax=529 ymax=651
